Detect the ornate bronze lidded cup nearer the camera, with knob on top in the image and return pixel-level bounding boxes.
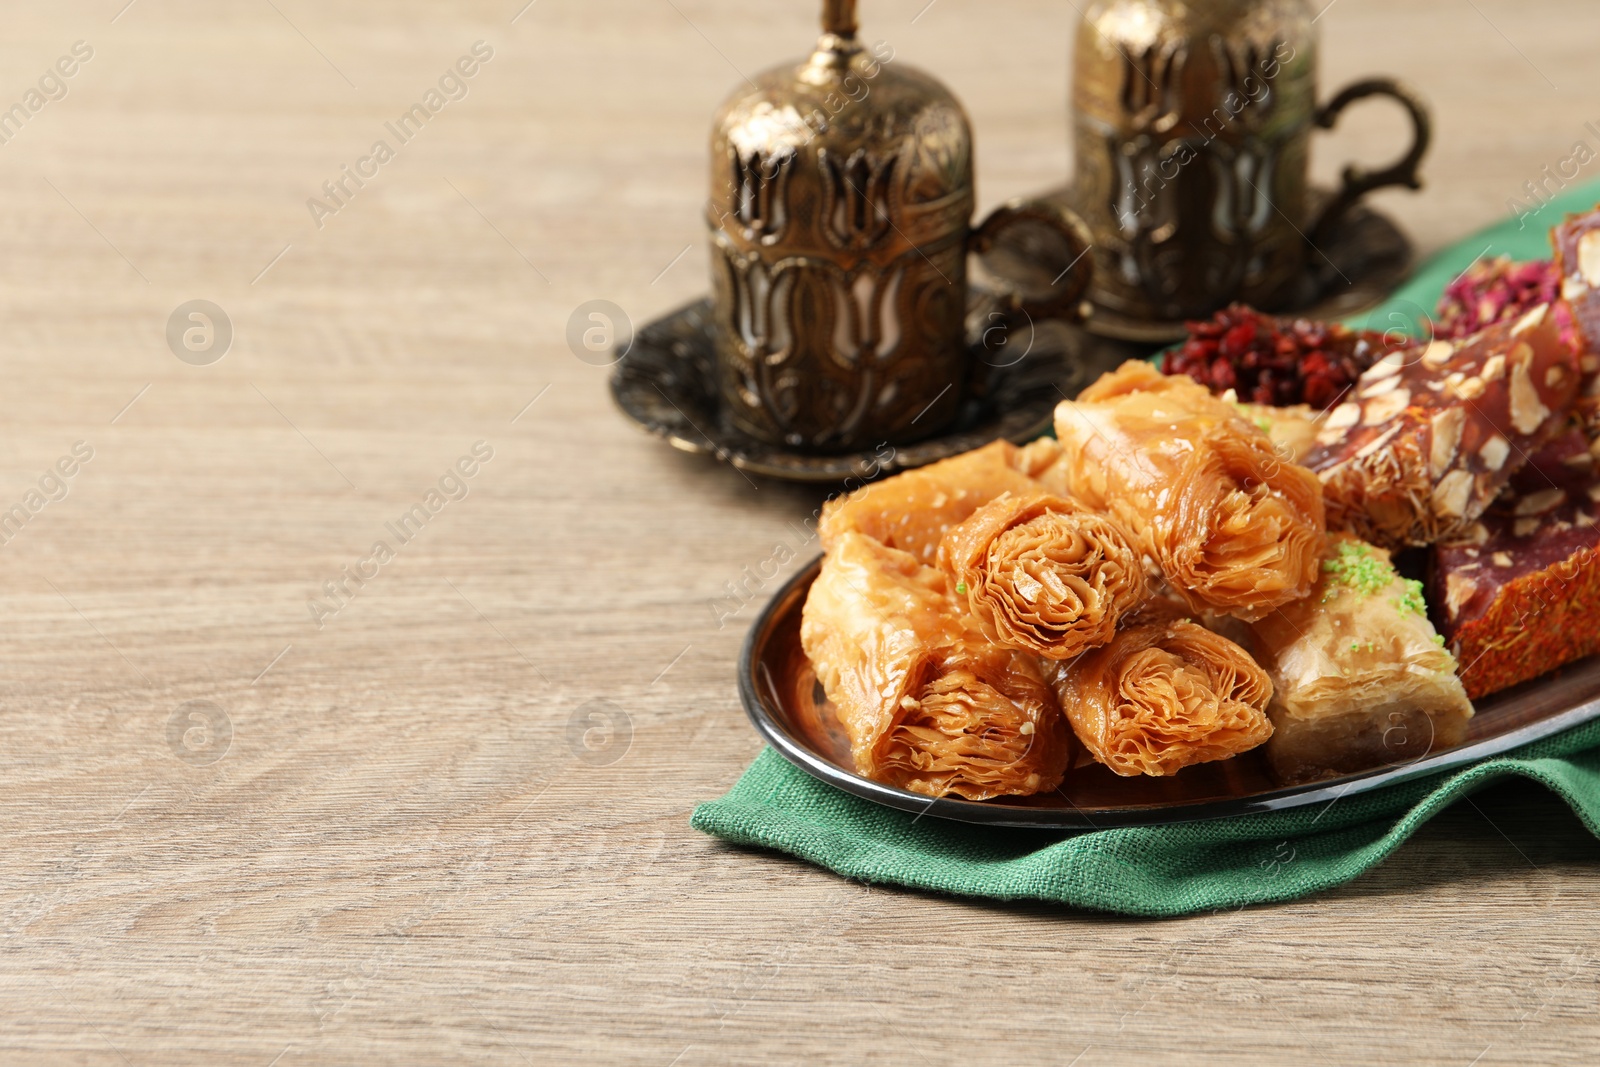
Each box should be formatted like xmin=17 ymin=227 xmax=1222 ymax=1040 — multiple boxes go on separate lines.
xmin=707 ymin=0 xmax=1093 ymax=453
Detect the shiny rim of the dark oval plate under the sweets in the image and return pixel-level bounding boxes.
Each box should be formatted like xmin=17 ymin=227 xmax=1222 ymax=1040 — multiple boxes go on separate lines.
xmin=738 ymin=555 xmax=1600 ymax=830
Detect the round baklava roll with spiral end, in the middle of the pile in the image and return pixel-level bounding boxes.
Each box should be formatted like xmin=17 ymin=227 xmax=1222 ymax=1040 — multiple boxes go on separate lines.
xmin=939 ymin=491 xmax=1147 ymax=659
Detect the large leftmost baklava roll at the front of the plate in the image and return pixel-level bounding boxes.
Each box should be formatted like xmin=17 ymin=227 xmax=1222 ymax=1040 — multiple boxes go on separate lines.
xmin=800 ymin=533 xmax=1070 ymax=800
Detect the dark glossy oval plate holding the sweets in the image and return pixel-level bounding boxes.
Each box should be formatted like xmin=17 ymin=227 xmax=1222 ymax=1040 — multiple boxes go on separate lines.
xmin=739 ymin=557 xmax=1600 ymax=830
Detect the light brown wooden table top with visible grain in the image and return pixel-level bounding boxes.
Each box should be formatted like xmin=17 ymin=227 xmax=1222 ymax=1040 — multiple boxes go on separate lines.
xmin=0 ymin=0 xmax=1600 ymax=1067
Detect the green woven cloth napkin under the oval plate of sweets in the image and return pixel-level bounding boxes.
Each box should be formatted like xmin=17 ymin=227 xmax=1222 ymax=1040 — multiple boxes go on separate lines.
xmin=693 ymin=182 xmax=1600 ymax=915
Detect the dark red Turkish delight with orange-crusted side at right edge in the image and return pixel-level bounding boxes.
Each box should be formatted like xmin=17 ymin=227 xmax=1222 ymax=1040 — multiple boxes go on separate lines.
xmin=1430 ymin=429 xmax=1600 ymax=697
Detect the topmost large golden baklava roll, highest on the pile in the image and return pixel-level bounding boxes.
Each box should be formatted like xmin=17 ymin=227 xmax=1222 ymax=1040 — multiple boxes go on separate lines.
xmin=1040 ymin=363 xmax=1323 ymax=619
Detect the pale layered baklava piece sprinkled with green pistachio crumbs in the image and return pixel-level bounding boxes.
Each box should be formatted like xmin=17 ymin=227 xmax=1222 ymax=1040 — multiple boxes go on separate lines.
xmin=1251 ymin=534 xmax=1472 ymax=782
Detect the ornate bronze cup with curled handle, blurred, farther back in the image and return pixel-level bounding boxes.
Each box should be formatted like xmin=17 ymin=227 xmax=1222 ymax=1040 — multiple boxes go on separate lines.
xmin=1070 ymin=0 xmax=1430 ymax=320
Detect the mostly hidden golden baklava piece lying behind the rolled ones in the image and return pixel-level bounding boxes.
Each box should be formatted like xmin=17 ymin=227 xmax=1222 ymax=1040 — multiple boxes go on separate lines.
xmin=818 ymin=442 xmax=1036 ymax=563
